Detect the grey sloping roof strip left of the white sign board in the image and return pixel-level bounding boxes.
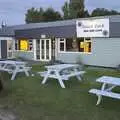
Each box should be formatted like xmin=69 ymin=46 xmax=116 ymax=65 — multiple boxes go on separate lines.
xmin=0 ymin=20 xmax=76 ymax=36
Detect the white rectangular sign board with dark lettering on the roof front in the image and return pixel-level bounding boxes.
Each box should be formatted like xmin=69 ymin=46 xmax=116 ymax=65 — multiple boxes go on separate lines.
xmin=76 ymin=19 xmax=109 ymax=37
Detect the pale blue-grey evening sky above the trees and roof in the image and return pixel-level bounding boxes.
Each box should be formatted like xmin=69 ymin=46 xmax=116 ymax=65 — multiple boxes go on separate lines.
xmin=0 ymin=0 xmax=120 ymax=25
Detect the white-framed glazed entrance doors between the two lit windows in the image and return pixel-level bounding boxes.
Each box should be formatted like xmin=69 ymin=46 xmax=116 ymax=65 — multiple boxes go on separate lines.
xmin=40 ymin=39 xmax=51 ymax=61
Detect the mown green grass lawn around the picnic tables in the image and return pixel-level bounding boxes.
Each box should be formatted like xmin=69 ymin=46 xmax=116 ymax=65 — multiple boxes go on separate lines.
xmin=0 ymin=65 xmax=120 ymax=120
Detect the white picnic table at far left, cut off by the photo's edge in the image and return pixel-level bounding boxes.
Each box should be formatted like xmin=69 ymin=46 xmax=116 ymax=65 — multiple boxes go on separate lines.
xmin=0 ymin=60 xmax=31 ymax=80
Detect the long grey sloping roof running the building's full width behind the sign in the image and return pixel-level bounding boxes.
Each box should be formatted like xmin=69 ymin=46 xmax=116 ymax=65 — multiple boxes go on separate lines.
xmin=0 ymin=15 xmax=120 ymax=36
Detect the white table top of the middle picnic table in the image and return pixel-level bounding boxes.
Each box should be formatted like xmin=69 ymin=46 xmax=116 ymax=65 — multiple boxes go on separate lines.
xmin=45 ymin=64 xmax=79 ymax=70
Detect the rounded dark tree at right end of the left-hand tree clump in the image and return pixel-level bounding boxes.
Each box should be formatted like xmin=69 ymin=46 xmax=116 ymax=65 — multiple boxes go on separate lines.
xmin=43 ymin=8 xmax=62 ymax=21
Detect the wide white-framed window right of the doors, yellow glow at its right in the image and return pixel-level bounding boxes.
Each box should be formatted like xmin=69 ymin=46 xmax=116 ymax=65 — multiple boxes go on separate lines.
xmin=59 ymin=38 xmax=91 ymax=53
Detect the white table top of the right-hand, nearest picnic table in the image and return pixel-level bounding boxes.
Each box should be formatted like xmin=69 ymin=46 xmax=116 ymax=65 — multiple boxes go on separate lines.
xmin=96 ymin=76 xmax=120 ymax=86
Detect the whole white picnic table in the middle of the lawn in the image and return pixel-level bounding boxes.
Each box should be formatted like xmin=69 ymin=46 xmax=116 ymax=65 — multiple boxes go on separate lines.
xmin=40 ymin=64 xmax=85 ymax=88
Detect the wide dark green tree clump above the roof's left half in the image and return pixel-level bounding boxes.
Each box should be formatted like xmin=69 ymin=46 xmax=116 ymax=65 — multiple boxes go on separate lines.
xmin=25 ymin=8 xmax=61 ymax=23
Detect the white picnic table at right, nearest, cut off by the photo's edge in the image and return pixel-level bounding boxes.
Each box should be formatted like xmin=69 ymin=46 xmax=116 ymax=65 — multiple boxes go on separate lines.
xmin=89 ymin=76 xmax=120 ymax=105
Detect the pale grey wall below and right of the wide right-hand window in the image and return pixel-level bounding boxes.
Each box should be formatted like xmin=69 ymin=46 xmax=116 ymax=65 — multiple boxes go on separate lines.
xmin=57 ymin=38 xmax=120 ymax=67
